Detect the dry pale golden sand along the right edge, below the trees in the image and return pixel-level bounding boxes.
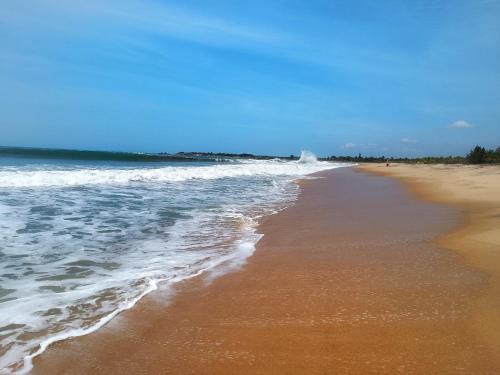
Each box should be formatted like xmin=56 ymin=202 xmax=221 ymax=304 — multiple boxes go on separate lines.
xmin=360 ymin=164 xmax=500 ymax=360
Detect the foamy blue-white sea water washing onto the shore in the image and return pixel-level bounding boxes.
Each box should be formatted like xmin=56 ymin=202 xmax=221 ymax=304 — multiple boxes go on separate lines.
xmin=0 ymin=153 xmax=341 ymax=373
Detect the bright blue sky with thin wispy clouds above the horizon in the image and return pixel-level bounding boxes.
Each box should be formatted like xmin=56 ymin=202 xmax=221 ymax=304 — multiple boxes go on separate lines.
xmin=0 ymin=0 xmax=500 ymax=156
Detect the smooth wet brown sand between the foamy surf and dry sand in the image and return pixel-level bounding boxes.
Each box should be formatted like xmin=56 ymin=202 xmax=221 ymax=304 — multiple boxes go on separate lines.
xmin=33 ymin=169 xmax=499 ymax=374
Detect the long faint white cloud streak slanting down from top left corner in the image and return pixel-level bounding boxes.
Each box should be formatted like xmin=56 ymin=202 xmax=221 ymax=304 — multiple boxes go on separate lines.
xmin=0 ymin=0 xmax=426 ymax=82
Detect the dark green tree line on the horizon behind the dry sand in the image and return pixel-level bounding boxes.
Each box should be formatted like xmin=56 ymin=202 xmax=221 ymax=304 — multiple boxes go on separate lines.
xmin=323 ymin=145 xmax=500 ymax=164
